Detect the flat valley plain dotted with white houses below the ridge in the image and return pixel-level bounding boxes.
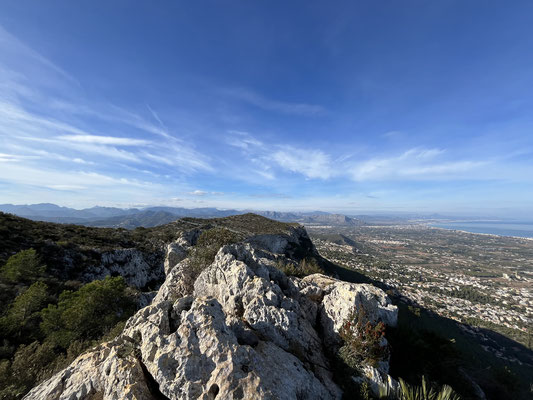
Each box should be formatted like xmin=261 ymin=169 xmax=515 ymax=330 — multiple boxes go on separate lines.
xmin=307 ymin=225 xmax=533 ymax=350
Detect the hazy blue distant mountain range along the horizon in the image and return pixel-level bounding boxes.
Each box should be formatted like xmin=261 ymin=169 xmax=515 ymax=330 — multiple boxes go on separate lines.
xmin=0 ymin=203 xmax=365 ymax=229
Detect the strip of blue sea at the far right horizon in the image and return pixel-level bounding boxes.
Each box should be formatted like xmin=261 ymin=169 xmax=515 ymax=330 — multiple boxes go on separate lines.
xmin=431 ymin=221 xmax=533 ymax=238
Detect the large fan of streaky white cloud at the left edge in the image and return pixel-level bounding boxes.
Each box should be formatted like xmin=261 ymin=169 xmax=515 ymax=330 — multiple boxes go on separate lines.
xmin=0 ymin=23 xmax=212 ymax=194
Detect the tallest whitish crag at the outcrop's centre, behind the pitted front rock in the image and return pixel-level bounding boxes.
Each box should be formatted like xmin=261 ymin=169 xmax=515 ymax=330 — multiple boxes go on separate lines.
xmin=194 ymin=244 xmax=335 ymax=392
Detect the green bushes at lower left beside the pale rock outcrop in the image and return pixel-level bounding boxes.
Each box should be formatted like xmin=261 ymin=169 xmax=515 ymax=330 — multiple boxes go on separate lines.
xmin=0 ymin=249 xmax=136 ymax=400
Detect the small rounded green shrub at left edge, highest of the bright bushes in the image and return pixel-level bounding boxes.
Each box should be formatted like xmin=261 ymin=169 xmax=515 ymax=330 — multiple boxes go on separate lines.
xmin=0 ymin=249 xmax=46 ymax=283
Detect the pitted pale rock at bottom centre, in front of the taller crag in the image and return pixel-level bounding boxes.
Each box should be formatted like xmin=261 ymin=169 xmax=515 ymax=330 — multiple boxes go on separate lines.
xmin=119 ymin=297 xmax=334 ymax=399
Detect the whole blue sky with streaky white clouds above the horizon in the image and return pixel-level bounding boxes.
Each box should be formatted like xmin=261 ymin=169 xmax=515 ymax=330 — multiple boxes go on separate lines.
xmin=0 ymin=0 xmax=533 ymax=217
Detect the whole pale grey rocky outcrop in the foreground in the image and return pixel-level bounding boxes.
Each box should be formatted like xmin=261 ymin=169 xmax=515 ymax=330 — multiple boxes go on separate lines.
xmin=25 ymin=228 xmax=397 ymax=400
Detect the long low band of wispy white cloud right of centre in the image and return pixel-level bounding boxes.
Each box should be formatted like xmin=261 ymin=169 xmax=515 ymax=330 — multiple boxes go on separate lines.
xmin=220 ymin=131 xmax=502 ymax=182
